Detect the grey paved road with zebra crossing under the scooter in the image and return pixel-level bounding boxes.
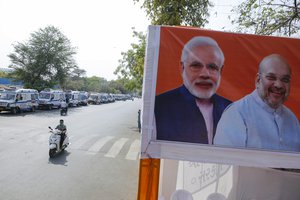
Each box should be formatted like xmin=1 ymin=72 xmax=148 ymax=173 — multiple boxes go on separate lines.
xmin=0 ymin=99 xmax=141 ymax=200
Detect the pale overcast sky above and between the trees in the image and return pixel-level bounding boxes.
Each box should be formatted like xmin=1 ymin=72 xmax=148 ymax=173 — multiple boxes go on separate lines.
xmin=0 ymin=0 xmax=237 ymax=80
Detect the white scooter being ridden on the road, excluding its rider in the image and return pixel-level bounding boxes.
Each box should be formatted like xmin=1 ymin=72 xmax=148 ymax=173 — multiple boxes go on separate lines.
xmin=48 ymin=126 xmax=69 ymax=158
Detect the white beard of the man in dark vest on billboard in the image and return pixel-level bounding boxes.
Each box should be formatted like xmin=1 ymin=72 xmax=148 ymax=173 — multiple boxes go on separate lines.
xmin=182 ymin=70 xmax=221 ymax=99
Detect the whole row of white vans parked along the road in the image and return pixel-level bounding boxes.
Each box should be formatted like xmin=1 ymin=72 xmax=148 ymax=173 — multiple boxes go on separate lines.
xmin=0 ymin=89 xmax=133 ymax=114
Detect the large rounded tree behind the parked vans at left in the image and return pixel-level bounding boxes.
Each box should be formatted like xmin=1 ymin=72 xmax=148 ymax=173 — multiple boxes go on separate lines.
xmin=8 ymin=26 xmax=77 ymax=90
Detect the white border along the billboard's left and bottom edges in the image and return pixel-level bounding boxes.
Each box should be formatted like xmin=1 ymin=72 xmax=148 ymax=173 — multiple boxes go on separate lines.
xmin=141 ymin=26 xmax=300 ymax=169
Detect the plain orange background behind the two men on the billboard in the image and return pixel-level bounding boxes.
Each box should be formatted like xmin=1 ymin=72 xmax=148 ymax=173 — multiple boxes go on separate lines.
xmin=156 ymin=26 xmax=300 ymax=119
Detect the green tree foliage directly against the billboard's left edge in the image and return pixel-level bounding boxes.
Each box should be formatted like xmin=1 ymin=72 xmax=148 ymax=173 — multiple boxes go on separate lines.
xmin=114 ymin=29 xmax=146 ymax=91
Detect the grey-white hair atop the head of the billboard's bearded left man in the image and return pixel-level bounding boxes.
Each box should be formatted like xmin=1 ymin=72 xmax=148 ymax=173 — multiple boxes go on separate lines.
xmin=181 ymin=36 xmax=225 ymax=67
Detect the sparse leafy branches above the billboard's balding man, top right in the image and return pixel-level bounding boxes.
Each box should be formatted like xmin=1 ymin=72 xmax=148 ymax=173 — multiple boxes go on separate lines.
xmin=232 ymin=0 xmax=300 ymax=36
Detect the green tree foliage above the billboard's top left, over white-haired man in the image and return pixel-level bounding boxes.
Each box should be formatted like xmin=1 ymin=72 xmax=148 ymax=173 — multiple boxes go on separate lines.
xmin=134 ymin=0 xmax=212 ymax=27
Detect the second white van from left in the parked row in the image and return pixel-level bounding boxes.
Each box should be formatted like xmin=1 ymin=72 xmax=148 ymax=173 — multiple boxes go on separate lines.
xmin=39 ymin=89 xmax=66 ymax=110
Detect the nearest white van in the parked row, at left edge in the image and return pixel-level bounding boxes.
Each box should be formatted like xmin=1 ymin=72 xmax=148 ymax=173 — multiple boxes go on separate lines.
xmin=0 ymin=89 xmax=39 ymax=114
